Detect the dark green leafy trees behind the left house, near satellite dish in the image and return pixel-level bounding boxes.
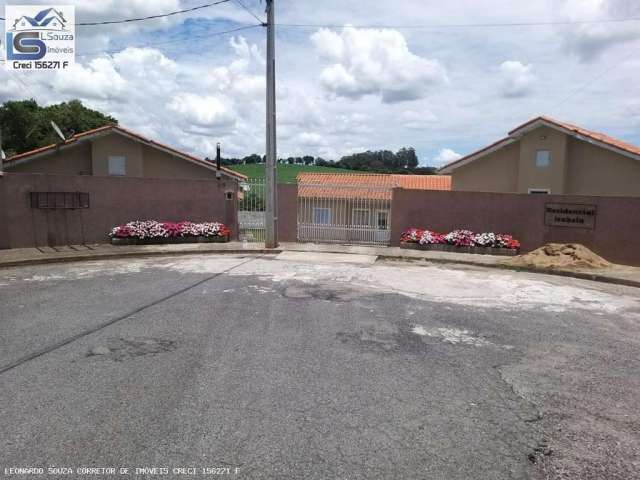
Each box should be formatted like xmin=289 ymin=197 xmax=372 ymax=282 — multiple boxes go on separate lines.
xmin=0 ymin=99 xmax=118 ymax=155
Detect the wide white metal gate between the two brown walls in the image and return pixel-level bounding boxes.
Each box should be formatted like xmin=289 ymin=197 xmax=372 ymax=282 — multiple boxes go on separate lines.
xmin=298 ymin=181 xmax=392 ymax=245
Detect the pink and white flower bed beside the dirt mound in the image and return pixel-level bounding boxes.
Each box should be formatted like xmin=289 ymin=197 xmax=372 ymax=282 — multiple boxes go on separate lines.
xmin=400 ymin=228 xmax=520 ymax=255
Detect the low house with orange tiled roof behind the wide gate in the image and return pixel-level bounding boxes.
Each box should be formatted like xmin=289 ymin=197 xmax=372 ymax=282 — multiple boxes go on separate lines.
xmin=298 ymin=172 xmax=451 ymax=244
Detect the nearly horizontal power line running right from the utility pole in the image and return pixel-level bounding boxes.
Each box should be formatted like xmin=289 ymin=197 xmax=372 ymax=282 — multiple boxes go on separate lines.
xmin=276 ymin=17 xmax=640 ymax=30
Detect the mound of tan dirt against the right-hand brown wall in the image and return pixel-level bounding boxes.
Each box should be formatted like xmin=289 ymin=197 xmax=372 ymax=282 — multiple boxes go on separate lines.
xmin=508 ymin=243 xmax=611 ymax=269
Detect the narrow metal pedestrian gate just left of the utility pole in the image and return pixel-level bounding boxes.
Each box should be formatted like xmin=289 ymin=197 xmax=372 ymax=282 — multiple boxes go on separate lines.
xmin=238 ymin=178 xmax=265 ymax=242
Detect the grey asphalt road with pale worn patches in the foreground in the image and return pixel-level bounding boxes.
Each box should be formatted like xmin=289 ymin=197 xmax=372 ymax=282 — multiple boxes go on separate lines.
xmin=0 ymin=254 xmax=640 ymax=480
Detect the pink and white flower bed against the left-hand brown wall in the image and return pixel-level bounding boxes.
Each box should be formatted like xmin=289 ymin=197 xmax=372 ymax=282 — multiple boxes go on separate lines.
xmin=109 ymin=220 xmax=231 ymax=245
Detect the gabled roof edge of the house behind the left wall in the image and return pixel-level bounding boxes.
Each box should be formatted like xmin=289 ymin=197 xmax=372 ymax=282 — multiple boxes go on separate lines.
xmin=4 ymin=125 xmax=247 ymax=180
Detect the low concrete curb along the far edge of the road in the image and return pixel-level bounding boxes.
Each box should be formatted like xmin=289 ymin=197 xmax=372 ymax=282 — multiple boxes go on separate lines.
xmin=0 ymin=248 xmax=640 ymax=288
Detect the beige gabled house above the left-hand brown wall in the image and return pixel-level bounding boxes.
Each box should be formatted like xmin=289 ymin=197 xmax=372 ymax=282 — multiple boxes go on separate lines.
xmin=4 ymin=125 xmax=246 ymax=182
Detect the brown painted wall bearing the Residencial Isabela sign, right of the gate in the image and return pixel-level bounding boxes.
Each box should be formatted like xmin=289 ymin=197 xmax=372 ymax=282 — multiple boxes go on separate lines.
xmin=391 ymin=189 xmax=640 ymax=266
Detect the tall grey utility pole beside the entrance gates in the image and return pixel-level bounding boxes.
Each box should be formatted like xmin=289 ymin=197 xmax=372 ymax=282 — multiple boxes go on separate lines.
xmin=264 ymin=0 xmax=278 ymax=248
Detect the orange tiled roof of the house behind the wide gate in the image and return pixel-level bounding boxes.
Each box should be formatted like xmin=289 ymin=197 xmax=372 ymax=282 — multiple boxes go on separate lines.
xmin=298 ymin=172 xmax=451 ymax=200
